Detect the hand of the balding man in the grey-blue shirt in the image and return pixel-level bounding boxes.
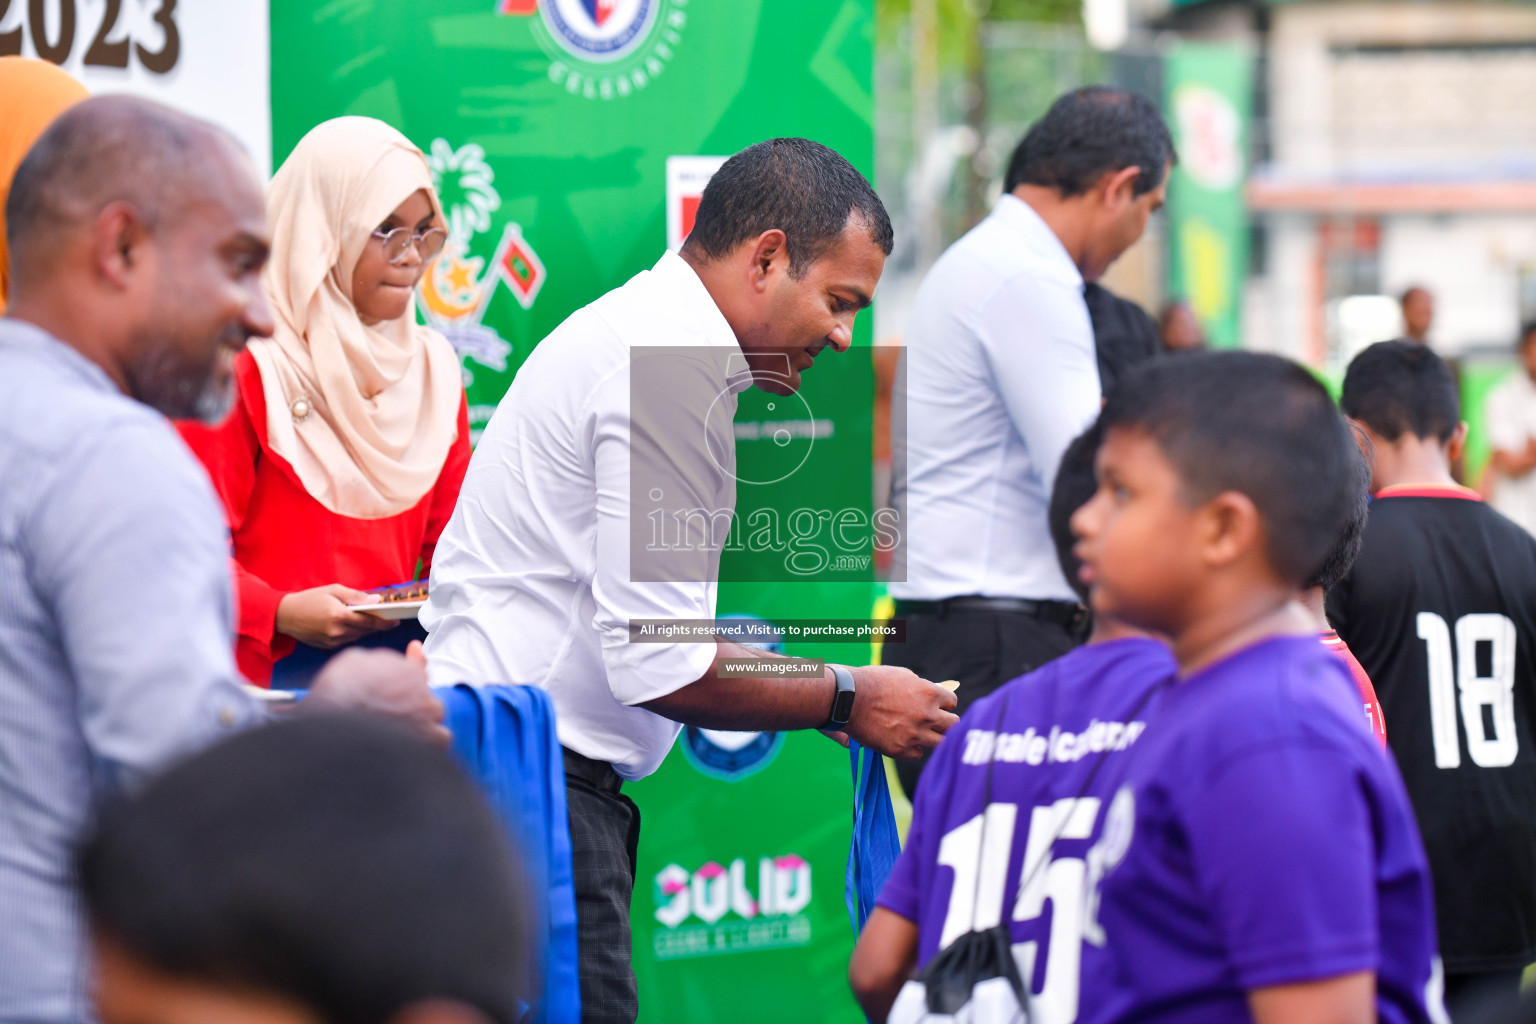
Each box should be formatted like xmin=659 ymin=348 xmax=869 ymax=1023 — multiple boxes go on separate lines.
xmin=300 ymin=640 xmax=450 ymax=746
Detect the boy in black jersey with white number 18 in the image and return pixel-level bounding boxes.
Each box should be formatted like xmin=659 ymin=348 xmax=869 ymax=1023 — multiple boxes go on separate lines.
xmin=1327 ymin=341 xmax=1536 ymax=1016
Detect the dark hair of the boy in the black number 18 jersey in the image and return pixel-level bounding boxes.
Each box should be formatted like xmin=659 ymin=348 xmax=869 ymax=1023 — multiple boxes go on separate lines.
xmin=1339 ymin=341 xmax=1461 ymax=442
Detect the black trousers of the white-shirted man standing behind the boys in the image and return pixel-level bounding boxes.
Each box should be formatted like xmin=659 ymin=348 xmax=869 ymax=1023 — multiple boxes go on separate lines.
xmin=882 ymin=608 xmax=1078 ymax=800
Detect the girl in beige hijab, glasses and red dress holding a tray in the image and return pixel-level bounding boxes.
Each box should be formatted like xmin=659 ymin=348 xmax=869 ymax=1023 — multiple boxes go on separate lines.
xmin=181 ymin=117 xmax=470 ymax=685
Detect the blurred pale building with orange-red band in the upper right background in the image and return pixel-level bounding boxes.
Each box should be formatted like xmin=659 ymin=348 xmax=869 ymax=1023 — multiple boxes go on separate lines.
xmin=1244 ymin=0 xmax=1536 ymax=365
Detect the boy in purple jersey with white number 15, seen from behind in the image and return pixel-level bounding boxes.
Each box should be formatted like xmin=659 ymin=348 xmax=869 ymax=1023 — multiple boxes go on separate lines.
xmin=849 ymin=425 xmax=1175 ymax=1024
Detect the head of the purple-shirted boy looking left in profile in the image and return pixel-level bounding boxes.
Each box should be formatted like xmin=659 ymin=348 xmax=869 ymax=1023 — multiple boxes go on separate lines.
xmin=1072 ymin=352 xmax=1359 ymax=643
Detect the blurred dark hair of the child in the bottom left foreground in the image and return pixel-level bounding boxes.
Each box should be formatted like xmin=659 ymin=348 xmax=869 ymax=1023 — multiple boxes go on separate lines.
xmin=78 ymin=714 xmax=530 ymax=1024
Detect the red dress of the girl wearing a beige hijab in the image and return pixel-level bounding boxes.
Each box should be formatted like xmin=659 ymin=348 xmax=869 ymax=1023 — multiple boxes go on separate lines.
xmin=177 ymin=352 xmax=470 ymax=686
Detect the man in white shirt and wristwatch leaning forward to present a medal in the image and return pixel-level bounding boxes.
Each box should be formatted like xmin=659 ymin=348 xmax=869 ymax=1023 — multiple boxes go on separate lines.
xmin=421 ymin=138 xmax=955 ymax=1022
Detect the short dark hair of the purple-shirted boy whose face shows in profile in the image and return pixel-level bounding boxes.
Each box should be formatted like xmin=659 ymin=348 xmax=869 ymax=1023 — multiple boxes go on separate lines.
xmin=1100 ymin=352 xmax=1359 ymax=588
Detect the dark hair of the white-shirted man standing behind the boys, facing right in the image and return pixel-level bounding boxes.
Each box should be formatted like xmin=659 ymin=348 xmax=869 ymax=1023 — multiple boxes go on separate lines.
xmin=1003 ymin=86 xmax=1178 ymax=197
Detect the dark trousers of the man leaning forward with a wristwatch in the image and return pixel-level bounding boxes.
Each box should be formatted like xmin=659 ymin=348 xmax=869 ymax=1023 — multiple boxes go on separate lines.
xmin=565 ymin=769 xmax=641 ymax=1024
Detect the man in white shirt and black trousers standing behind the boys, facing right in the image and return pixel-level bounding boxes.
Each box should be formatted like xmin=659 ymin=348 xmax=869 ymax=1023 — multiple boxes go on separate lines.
xmin=885 ymin=86 xmax=1174 ymax=795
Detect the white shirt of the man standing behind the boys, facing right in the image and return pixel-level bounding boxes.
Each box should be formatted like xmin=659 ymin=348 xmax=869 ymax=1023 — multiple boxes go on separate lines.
xmin=891 ymin=195 xmax=1100 ymax=602
